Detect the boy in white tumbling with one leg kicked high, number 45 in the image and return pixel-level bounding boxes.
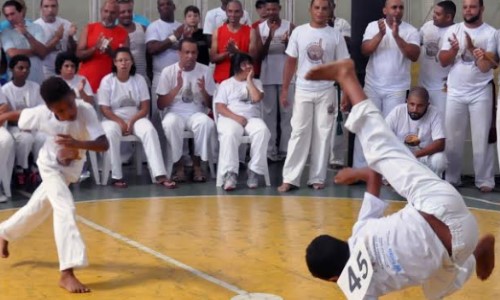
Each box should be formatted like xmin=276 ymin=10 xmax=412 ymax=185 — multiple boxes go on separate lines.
xmin=306 ymin=60 xmax=495 ymax=299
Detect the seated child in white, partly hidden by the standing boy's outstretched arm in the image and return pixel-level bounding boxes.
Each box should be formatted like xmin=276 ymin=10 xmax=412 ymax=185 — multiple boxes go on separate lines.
xmin=2 ymin=55 xmax=45 ymax=185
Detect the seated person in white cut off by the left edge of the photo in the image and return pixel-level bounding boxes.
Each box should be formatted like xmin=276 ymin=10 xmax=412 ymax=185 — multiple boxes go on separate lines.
xmin=0 ymin=94 xmax=15 ymax=203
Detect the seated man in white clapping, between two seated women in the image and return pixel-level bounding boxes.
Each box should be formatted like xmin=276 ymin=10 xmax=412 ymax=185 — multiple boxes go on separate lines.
xmin=156 ymin=38 xmax=216 ymax=182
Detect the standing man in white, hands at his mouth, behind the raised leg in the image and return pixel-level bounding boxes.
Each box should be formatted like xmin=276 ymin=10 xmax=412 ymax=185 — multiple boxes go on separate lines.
xmin=353 ymin=0 xmax=420 ymax=167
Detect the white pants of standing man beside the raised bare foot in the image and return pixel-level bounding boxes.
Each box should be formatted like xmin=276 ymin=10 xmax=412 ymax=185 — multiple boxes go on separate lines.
xmin=283 ymin=86 xmax=337 ymax=186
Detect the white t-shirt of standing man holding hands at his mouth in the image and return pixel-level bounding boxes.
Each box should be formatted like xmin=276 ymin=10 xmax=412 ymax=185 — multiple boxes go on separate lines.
xmin=363 ymin=21 xmax=420 ymax=92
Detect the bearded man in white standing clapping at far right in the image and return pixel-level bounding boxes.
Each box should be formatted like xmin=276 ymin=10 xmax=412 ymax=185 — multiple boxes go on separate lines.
xmin=439 ymin=0 xmax=496 ymax=192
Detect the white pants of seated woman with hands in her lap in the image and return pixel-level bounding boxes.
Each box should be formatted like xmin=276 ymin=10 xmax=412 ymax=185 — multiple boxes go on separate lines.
xmin=101 ymin=118 xmax=167 ymax=179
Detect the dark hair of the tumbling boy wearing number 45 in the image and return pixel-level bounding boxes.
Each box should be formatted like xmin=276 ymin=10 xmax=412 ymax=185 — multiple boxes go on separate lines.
xmin=306 ymin=235 xmax=350 ymax=280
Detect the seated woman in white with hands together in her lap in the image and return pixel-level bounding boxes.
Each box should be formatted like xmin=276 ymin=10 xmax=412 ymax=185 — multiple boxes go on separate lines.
xmin=97 ymin=48 xmax=175 ymax=188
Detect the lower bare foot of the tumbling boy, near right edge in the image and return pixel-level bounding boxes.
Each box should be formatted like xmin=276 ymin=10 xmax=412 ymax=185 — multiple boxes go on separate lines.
xmin=474 ymin=234 xmax=495 ymax=280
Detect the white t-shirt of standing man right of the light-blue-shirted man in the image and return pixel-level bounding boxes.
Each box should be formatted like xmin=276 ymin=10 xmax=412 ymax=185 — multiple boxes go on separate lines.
xmin=34 ymin=17 xmax=71 ymax=75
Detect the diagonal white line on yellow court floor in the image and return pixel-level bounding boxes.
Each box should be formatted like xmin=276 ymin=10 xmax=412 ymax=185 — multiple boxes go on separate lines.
xmin=76 ymin=216 xmax=248 ymax=295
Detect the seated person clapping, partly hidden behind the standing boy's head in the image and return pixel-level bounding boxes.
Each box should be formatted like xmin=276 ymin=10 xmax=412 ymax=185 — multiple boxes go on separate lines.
xmin=55 ymin=52 xmax=94 ymax=106
